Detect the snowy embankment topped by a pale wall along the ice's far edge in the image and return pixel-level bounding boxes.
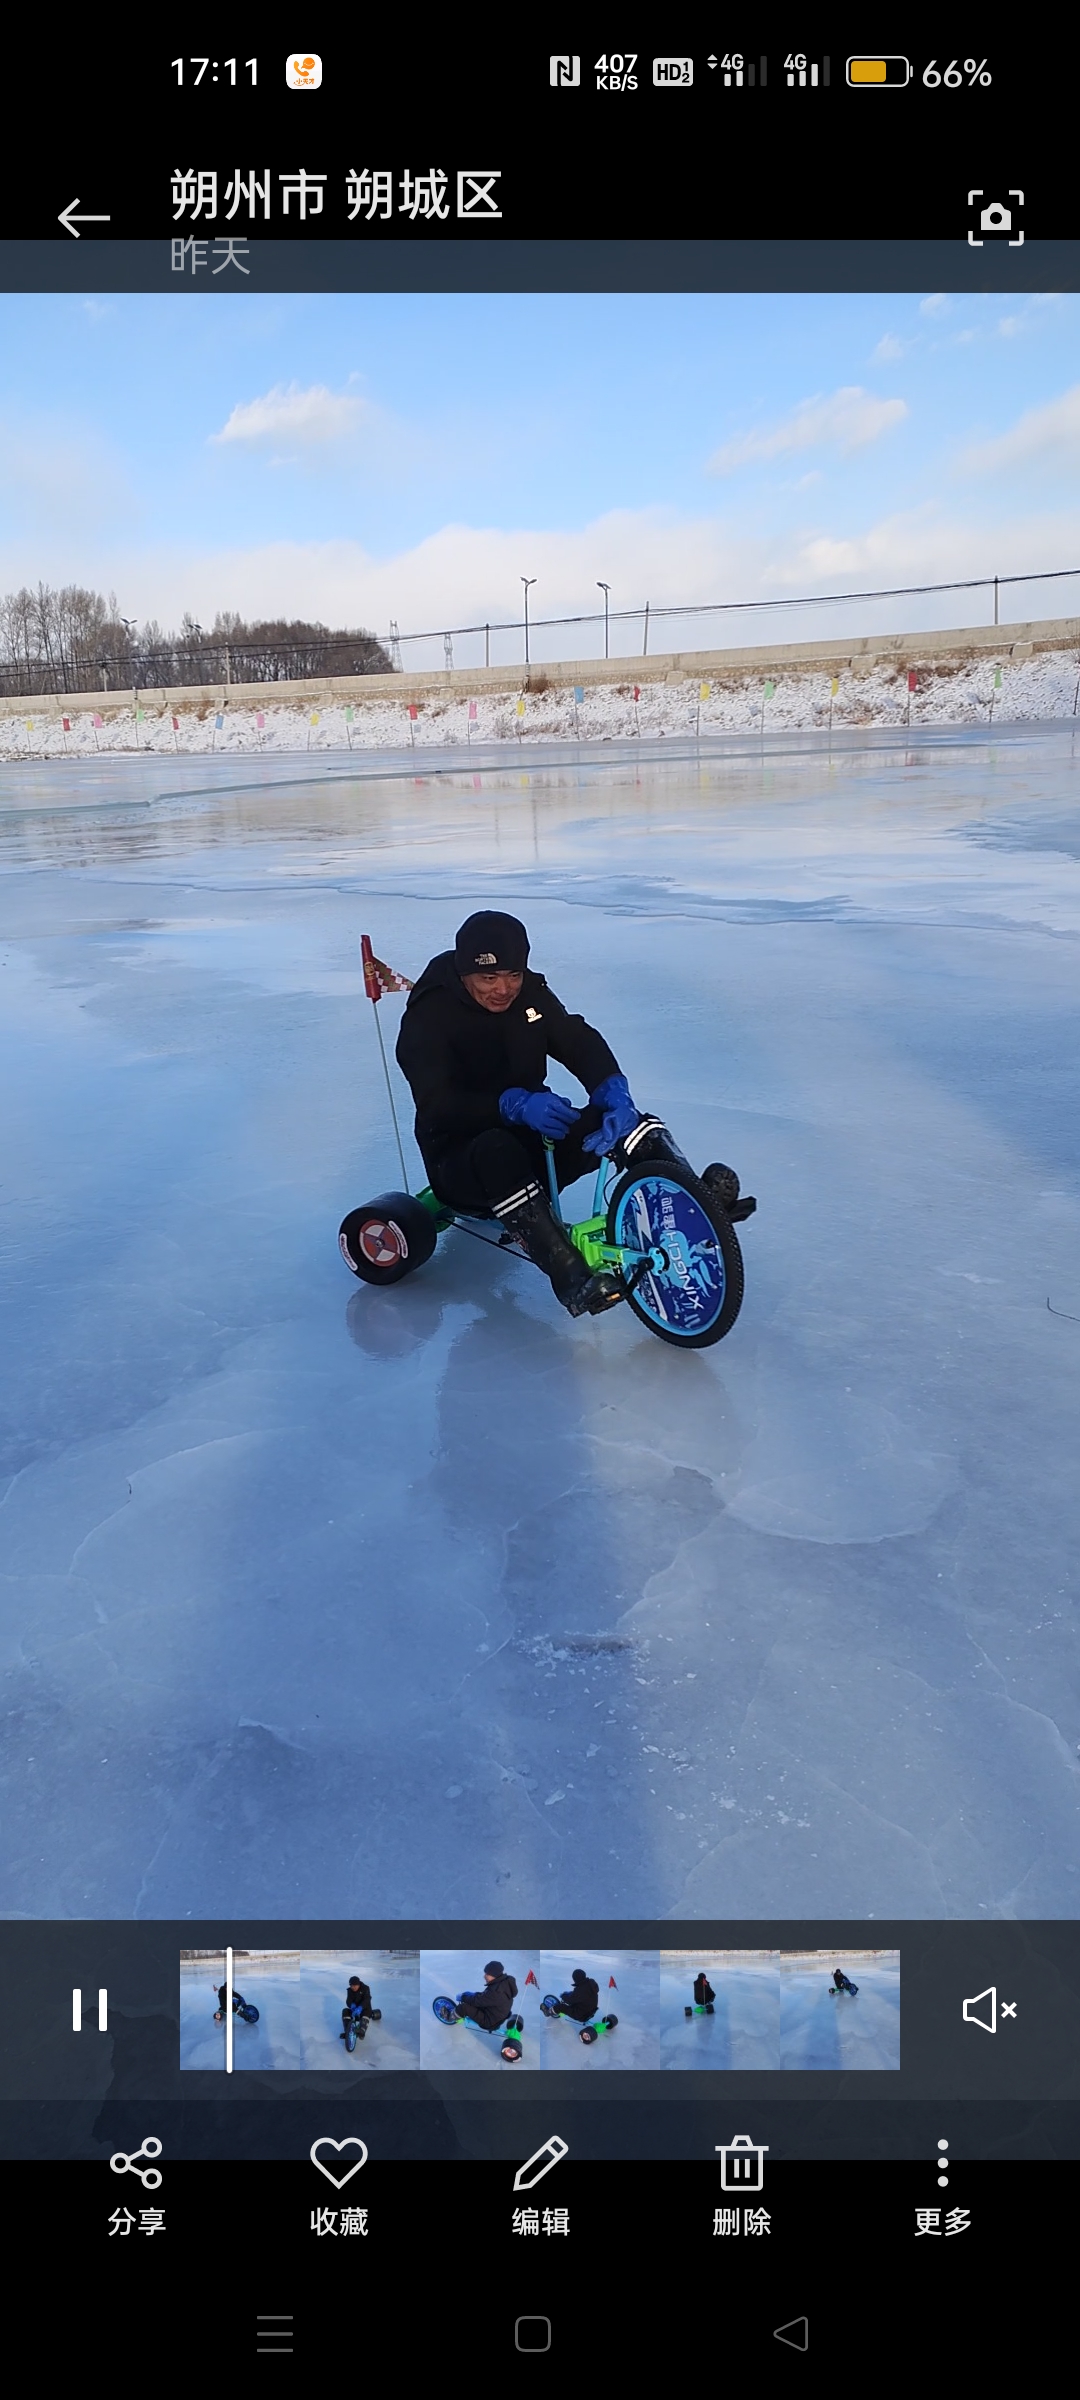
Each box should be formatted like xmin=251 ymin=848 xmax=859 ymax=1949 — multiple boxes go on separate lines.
xmin=0 ymin=617 xmax=1080 ymax=758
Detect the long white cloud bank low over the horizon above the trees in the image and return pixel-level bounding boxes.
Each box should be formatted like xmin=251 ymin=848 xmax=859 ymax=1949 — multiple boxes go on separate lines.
xmin=0 ymin=497 xmax=1080 ymax=667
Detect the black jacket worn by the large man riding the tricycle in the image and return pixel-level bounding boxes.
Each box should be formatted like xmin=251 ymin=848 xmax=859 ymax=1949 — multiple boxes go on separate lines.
xmin=396 ymin=950 xmax=619 ymax=1174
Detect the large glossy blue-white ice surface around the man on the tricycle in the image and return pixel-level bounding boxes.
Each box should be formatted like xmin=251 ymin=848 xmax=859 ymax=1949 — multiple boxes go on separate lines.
xmin=0 ymin=727 xmax=1080 ymax=1939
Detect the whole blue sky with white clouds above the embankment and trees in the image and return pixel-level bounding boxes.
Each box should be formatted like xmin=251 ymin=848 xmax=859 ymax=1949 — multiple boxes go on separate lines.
xmin=0 ymin=290 xmax=1080 ymax=665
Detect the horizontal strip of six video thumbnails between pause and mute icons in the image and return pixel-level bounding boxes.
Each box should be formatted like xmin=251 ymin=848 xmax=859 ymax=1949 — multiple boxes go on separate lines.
xmin=180 ymin=1946 xmax=900 ymax=2074
